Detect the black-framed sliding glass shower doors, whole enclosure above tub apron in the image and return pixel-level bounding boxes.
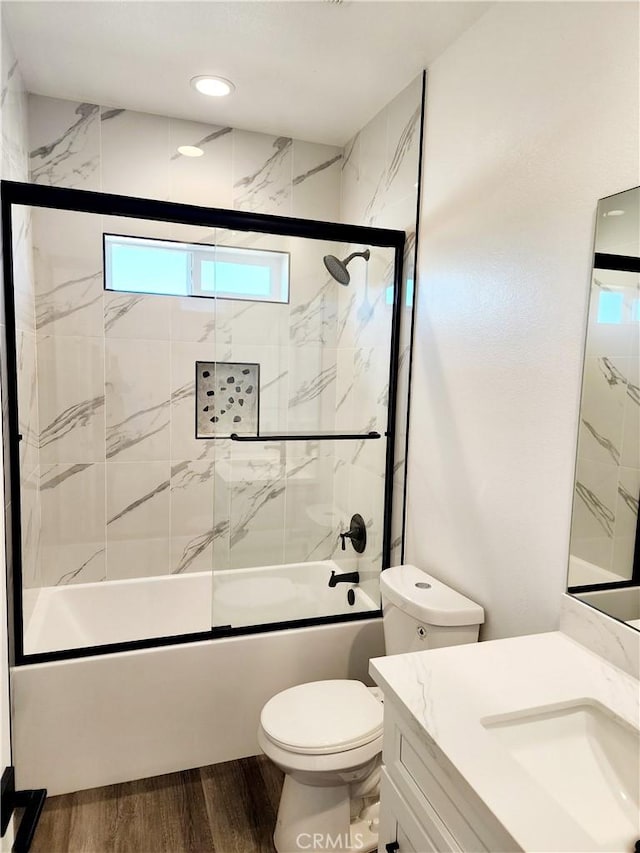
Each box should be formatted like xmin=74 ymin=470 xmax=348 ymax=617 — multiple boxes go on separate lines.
xmin=2 ymin=182 xmax=404 ymax=664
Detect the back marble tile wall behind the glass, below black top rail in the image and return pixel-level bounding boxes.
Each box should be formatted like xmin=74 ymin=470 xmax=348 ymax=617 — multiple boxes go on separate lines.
xmin=28 ymin=216 xmax=350 ymax=583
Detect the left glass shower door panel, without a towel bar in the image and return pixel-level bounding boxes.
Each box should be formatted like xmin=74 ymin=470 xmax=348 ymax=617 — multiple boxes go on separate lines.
xmin=12 ymin=206 xmax=228 ymax=654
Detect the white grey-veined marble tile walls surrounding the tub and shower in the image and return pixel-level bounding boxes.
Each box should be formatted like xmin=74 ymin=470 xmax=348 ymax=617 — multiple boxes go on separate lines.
xmin=18 ymin=80 xmax=422 ymax=598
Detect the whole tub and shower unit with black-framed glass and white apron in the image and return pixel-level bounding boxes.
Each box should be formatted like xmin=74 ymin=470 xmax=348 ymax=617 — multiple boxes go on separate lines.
xmin=2 ymin=182 xmax=405 ymax=794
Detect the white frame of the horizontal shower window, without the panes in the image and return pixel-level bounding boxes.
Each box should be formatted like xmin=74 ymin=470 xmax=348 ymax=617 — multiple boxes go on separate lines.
xmin=102 ymin=232 xmax=290 ymax=304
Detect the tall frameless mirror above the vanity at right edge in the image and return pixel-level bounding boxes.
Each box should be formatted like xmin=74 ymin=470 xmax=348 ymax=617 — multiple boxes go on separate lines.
xmin=568 ymin=187 xmax=640 ymax=630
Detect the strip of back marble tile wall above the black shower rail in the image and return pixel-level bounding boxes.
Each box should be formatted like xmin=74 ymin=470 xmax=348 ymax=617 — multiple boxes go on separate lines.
xmin=29 ymin=95 xmax=342 ymax=221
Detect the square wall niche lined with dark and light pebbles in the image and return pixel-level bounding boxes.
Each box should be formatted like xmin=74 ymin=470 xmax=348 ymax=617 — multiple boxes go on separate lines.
xmin=196 ymin=361 xmax=260 ymax=438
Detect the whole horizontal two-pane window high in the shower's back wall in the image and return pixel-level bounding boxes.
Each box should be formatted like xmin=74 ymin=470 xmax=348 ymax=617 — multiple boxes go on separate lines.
xmin=103 ymin=234 xmax=289 ymax=303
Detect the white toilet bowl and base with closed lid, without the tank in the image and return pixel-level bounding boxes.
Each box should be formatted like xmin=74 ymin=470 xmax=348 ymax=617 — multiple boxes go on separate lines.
xmin=258 ymin=679 xmax=382 ymax=853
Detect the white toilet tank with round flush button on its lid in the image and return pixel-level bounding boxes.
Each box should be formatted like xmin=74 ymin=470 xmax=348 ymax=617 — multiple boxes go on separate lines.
xmin=380 ymin=565 xmax=484 ymax=655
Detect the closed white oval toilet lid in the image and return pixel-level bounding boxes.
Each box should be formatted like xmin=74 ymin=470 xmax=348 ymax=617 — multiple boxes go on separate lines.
xmin=260 ymin=679 xmax=382 ymax=754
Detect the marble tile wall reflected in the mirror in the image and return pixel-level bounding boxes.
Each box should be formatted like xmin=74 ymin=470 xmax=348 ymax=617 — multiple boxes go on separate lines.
xmin=571 ymin=270 xmax=640 ymax=580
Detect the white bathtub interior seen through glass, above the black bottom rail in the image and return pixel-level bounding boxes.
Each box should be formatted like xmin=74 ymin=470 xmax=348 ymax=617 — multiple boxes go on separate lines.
xmin=24 ymin=560 xmax=380 ymax=654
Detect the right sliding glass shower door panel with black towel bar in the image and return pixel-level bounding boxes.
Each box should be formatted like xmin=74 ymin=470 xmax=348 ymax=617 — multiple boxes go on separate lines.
xmin=207 ymin=229 xmax=394 ymax=630
